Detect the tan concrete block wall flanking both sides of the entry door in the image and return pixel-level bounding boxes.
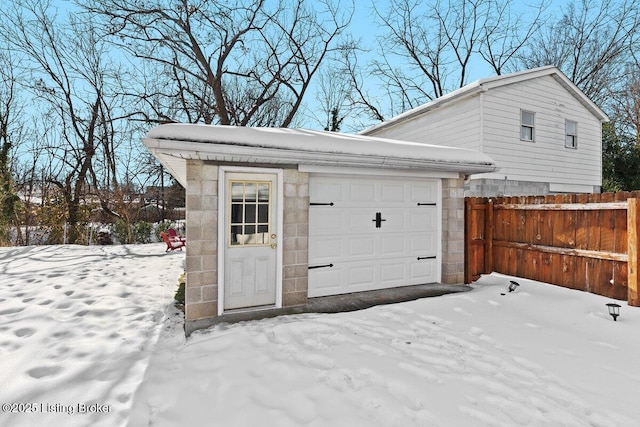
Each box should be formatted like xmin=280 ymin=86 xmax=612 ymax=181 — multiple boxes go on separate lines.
xmin=185 ymin=165 xmax=309 ymax=329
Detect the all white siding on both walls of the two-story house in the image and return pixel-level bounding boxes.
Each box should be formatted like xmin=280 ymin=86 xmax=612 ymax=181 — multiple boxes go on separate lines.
xmin=370 ymin=76 xmax=602 ymax=190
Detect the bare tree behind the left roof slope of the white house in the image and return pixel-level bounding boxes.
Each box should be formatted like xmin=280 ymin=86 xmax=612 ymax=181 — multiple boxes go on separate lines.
xmin=358 ymin=0 xmax=548 ymax=122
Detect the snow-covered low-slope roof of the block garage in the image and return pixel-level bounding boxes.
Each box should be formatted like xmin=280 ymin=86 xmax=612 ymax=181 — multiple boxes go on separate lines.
xmin=143 ymin=124 xmax=497 ymax=185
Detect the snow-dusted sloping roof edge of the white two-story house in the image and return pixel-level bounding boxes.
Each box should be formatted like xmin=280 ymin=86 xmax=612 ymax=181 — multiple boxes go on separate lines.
xmin=360 ymin=65 xmax=609 ymax=135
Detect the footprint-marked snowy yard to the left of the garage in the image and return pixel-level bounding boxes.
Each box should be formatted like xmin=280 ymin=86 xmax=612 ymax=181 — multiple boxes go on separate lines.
xmin=0 ymin=243 xmax=184 ymax=426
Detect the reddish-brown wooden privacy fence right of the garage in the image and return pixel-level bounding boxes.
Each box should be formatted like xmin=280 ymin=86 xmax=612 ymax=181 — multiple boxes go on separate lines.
xmin=465 ymin=192 xmax=640 ymax=306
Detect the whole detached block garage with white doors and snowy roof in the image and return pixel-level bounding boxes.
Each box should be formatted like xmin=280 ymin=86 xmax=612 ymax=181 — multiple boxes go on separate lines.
xmin=144 ymin=124 xmax=496 ymax=333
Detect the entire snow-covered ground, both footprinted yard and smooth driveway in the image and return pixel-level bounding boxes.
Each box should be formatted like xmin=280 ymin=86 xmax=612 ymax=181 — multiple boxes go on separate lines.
xmin=0 ymin=244 xmax=640 ymax=427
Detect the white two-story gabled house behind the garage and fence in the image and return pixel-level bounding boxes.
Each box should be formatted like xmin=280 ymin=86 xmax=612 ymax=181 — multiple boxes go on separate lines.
xmin=361 ymin=66 xmax=609 ymax=196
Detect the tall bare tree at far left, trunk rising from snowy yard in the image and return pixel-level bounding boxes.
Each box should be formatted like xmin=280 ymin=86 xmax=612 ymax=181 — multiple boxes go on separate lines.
xmin=0 ymin=0 xmax=135 ymax=243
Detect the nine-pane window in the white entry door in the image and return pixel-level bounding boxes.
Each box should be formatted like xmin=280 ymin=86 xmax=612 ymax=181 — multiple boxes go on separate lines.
xmin=229 ymin=181 xmax=271 ymax=246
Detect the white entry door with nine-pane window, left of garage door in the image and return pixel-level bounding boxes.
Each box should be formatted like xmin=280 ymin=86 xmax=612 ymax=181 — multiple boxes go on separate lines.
xmin=223 ymin=172 xmax=279 ymax=310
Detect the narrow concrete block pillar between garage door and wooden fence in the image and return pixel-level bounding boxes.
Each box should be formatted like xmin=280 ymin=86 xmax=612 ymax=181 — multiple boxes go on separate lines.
xmin=442 ymin=178 xmax=464 ymax=284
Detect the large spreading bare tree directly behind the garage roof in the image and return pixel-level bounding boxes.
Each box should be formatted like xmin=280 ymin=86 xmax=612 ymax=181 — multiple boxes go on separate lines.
xmin=80 ymin=0 xmax=352 ymax=127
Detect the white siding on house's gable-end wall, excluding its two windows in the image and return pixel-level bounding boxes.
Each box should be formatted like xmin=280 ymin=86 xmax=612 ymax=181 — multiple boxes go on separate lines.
xmin=478 ymin=76 xmax=602 ymax=186
